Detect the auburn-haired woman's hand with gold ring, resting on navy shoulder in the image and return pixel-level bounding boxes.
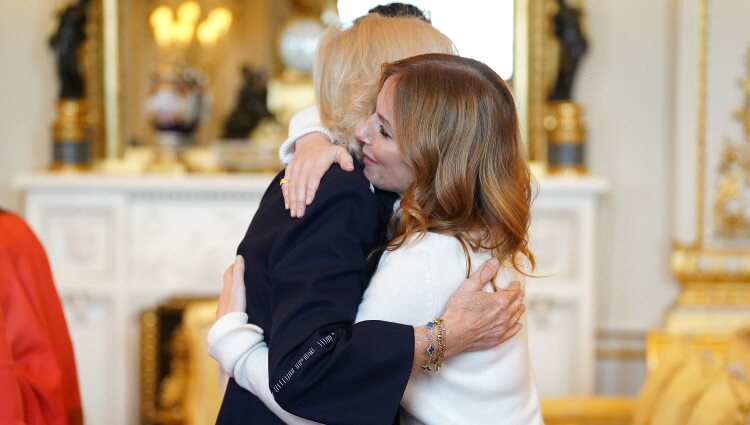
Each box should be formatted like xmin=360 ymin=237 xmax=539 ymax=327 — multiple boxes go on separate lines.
xmin=281 ymin=133 xmax=354 ymax=217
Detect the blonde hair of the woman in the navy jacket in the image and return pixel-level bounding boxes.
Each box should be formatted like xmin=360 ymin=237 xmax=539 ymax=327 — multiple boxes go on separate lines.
xmin=313 ymin=13 xmax=456 ymax=157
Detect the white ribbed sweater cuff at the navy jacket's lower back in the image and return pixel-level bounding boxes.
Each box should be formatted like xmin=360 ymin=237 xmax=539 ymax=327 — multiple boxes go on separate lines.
xmin=208 ymin=312 xmax=263 ymax=376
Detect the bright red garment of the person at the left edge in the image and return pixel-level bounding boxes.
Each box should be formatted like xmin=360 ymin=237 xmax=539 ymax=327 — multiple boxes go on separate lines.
xmin=0 ymin=211 xmax=81 ymax=425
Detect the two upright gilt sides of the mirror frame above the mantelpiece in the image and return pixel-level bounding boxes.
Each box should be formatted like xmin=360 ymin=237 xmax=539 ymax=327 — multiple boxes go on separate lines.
xmin=84 ymin=0 xmax=560 ymax=164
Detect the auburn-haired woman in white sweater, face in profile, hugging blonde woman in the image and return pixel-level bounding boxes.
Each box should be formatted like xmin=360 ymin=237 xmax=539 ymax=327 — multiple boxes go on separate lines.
xmin=356 ymin=54 xmax=542 ymax=425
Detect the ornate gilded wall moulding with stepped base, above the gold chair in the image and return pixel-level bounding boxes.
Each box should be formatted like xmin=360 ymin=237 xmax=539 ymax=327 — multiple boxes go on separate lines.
xmin=665 ymin=0 xmax=750 ymax=335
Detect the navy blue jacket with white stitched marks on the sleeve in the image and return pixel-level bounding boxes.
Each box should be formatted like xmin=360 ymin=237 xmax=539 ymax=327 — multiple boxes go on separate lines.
xmin=217 ymin=164 xmax=414 ymax=425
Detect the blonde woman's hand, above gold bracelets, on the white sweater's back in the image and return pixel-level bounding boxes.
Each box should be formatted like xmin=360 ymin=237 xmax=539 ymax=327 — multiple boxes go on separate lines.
xmin=443 ymin=258 xmax=526 ymax=357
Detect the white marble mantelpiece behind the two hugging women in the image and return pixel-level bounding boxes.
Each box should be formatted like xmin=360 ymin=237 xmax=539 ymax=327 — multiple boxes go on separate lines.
xmin=15 ymin=173 xmax=607 ymax=424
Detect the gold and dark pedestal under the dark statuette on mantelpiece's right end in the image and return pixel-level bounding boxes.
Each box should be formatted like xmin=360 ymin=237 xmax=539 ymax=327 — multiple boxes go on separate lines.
xmin=544 ymin=100 xmax=586 ymax=174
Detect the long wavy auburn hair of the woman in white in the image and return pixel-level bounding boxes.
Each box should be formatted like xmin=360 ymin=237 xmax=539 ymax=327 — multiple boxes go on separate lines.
xmin=380 ymin=54 xmax=535 ymax=275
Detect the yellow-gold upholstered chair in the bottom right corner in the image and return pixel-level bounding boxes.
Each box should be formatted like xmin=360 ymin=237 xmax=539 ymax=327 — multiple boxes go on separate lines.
xmin=542 ymin=330 xmax=750 ymax=425
